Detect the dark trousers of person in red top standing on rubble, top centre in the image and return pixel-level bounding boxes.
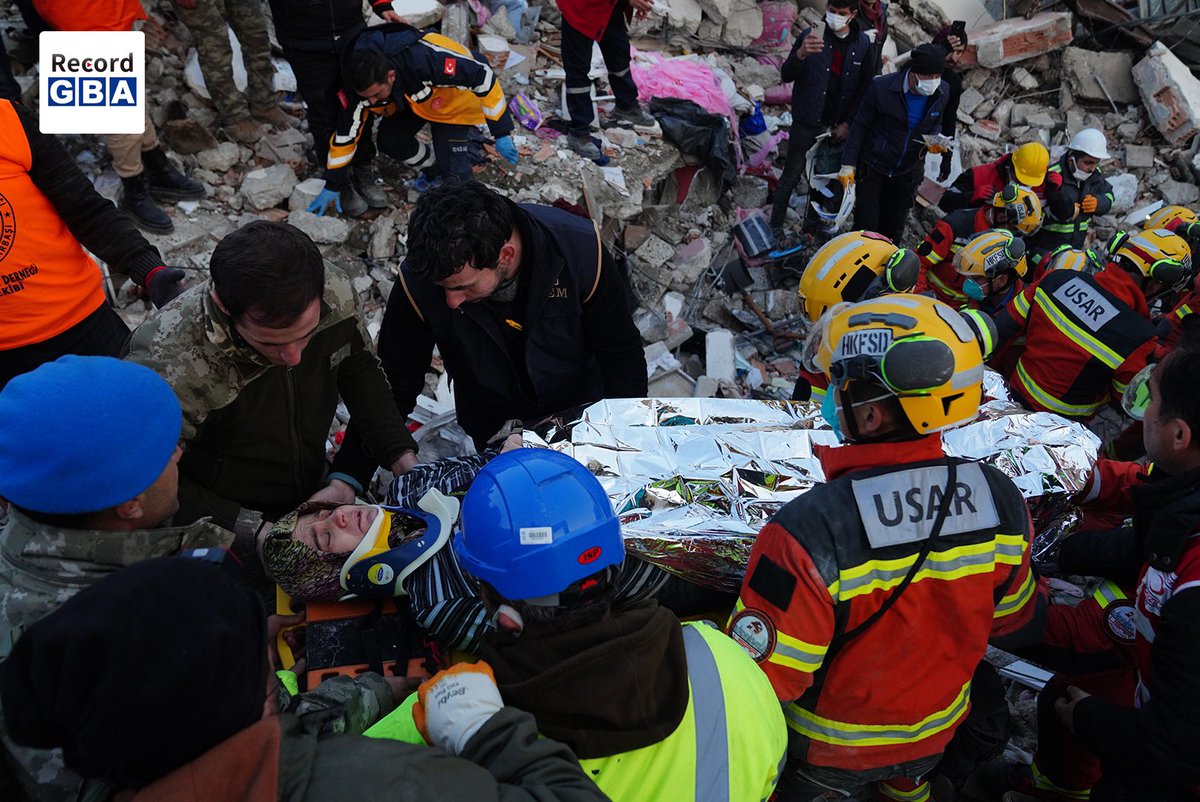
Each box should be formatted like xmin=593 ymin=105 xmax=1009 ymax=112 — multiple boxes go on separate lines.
xmin=563 ymin=2 xmax=637 ymax=134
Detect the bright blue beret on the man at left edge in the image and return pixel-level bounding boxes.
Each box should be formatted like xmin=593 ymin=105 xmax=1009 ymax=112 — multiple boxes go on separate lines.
xmin=0 ymin=355 xmax=184 ymax=514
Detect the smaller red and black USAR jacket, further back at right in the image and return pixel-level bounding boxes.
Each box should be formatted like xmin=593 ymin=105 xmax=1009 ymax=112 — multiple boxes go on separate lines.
xmin=995 ymin=263 xmax=1158 ymax=420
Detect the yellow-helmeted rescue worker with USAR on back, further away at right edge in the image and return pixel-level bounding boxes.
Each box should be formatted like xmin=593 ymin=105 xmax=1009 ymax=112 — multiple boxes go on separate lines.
xmin=996 ymin=229 xmax=1192 ymax=420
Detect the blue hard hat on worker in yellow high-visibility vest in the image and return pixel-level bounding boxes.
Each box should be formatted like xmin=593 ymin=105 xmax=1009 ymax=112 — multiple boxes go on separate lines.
xmin=454 ymin=448 xmax=625 ymax=600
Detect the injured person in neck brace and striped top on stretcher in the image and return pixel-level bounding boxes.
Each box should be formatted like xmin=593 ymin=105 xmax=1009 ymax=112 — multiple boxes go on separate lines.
xmin=262 ymin=435 xmax=668 ymax=654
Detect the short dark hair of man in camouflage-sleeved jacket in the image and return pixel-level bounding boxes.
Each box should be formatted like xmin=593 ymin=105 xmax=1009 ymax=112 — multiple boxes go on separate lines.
xmin=209 ymin=220 xmax=325 ymax=329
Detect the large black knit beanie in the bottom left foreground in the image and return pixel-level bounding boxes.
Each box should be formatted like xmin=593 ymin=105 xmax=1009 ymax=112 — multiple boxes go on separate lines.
xmin=0 ymin=557 xmax=268 ymax=788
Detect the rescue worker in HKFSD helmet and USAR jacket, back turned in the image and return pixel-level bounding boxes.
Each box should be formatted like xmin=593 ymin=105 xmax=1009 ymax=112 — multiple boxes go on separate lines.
xmin=728 ymin=295 xmax=1040 ymax=800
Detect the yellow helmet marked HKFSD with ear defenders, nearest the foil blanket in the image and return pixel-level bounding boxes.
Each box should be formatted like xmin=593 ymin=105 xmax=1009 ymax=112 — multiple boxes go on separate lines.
xmin=816 ymin=295 xmax=995 ymax=435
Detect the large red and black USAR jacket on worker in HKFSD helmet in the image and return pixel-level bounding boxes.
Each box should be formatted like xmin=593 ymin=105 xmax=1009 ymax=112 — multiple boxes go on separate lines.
xmin=730 ymin=435 xmax=1039 ymax=792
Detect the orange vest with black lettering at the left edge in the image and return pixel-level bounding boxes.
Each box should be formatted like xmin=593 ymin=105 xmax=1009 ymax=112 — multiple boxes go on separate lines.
xmin=0 ymin=102 xmax=104 ymax=349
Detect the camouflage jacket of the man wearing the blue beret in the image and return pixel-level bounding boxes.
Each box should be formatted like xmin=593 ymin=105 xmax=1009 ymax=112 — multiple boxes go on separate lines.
xmin=0 ymin=507 xmax=233 ymax=801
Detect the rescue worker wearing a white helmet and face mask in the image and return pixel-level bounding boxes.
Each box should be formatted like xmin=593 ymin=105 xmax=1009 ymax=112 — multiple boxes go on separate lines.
xmin=1030 ymin=128 xmax=1112 ymax=253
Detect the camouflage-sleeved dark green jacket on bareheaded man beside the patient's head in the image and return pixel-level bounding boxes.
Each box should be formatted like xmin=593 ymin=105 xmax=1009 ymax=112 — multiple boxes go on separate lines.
xmin=127 ymin=262 xmax=416 ymax=534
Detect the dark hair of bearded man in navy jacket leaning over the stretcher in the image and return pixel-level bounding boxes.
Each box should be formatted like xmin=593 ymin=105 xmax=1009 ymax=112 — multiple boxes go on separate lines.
xmin=408 ymin=180 xmax=514 ymax=281
